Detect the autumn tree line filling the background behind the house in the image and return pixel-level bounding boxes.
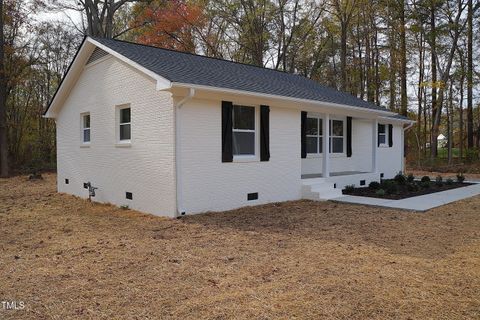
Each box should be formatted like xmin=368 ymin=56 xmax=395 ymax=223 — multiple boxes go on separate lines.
xmin=0 ymin=0 xmax=480 ymax=176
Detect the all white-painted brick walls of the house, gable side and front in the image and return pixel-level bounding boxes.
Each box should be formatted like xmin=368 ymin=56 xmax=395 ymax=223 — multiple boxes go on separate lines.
xmin=56 ymin=51 xmax=403 ymax=217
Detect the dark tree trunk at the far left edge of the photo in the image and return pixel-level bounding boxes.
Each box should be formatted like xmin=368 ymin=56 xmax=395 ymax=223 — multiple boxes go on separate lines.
xmin=0 ymin=0 xmax=9 ymax=177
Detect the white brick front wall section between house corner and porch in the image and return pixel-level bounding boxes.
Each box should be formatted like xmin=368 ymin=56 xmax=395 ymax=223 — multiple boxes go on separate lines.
xmin=180 ymin=99 xmax=301 ymax=214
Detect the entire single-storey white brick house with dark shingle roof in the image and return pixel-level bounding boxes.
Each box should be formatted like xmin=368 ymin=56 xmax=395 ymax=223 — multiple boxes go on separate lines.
xmin=45 ymin=38 xmax=412 ymax=217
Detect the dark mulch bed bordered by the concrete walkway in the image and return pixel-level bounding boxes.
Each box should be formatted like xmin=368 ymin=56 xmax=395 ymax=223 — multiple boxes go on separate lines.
xmin=342 ymin=181 xmax=471 ymax=200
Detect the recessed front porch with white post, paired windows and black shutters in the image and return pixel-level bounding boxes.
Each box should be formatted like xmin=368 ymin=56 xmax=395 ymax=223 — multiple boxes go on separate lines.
xmin=301 ymin=112 xmax=384 ymax=179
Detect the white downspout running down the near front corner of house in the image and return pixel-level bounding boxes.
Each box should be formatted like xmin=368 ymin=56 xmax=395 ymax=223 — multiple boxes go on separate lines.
xmin=174 ymin=88 xmax=195 ymax=218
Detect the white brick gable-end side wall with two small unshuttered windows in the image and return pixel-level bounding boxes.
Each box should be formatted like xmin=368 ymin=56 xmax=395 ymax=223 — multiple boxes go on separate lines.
xmin=56 ymin=58 xmax=176 ymax=216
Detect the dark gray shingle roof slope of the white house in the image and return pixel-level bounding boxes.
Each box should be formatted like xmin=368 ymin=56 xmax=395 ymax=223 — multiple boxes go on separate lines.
xmin=93 ymin=38 xmax=394 ymax=111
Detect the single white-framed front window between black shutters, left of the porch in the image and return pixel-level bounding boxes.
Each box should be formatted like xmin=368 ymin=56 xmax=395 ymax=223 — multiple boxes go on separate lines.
xmin=232 ymin=105 xmax=257 ymax=158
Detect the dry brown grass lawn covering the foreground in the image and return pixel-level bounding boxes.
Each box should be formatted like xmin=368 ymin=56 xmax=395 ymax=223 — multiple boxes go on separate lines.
xmin=0 ymin=175 xmax=480 ymax=319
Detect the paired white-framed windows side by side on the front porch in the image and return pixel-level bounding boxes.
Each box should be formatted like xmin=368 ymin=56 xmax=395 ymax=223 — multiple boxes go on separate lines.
xmin=306 ymin=115 xmax=345 ymax=155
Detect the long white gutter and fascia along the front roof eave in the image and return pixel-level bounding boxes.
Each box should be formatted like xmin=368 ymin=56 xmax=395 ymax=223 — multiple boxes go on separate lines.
xmin=171 ymin=82 xmax=396 ymax=118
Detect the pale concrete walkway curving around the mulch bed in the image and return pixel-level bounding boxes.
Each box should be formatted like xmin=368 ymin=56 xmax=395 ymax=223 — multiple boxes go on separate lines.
xmin=332 ymin=181 xmax=480 ymax=211
